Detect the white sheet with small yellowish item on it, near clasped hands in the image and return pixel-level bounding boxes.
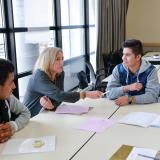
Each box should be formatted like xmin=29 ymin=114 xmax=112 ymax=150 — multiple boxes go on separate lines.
xmin=2 ymin=136 xmax=55 ymax=155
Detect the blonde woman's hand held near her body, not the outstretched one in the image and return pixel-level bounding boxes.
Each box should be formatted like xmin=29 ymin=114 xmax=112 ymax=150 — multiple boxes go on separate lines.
xmin=40 ymin=96 xmax=54 ymax=109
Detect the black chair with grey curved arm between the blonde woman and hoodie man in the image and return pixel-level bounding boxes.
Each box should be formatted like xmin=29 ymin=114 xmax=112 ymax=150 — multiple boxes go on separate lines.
xmin=86 ymin=62 xmax=107 ymax=92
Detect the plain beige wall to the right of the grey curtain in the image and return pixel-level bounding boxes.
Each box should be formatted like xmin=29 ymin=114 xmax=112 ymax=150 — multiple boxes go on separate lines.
xmin=126 ymin=0 xmax=160 ymax=43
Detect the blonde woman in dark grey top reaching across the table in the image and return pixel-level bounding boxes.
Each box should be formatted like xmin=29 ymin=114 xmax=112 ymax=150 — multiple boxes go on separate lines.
xmin=23 ymin=47 xmax=102 ymax=117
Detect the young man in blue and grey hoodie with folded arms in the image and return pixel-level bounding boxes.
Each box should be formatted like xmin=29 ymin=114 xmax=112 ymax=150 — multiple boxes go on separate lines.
xmin=107 ymin=39 xmax=159 ymax=106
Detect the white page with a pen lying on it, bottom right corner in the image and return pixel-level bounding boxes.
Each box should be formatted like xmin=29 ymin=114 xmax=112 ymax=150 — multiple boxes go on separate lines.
xmin=127 ymin=147 xmax=157 ymax=160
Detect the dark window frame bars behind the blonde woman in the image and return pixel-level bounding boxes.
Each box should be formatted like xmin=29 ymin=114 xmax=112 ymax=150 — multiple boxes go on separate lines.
xmin=0 ymin=0 xmax=95 ymax=98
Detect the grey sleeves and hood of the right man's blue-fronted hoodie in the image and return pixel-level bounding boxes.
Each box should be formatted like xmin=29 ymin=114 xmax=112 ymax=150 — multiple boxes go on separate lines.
xmin=106 ymin=59 xmax=160 ymax=104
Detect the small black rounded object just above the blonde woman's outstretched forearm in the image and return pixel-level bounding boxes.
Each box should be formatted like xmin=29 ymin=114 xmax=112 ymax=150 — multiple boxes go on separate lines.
xmin=77 ymin=71 xmax=88 ymax=89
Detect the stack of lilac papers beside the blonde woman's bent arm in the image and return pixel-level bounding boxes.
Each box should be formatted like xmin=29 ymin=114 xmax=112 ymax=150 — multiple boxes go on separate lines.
xmin=55 ymin=104 xmax=89 ymax=114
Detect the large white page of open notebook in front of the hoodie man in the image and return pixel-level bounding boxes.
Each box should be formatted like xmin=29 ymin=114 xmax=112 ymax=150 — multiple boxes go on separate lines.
xmin=118 ymin=112 xmax=157 ymax=127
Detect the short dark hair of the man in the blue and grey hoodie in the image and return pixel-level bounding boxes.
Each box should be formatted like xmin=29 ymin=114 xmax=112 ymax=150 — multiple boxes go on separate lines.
xmin=122 ymin=39 xmax=143 ymax=56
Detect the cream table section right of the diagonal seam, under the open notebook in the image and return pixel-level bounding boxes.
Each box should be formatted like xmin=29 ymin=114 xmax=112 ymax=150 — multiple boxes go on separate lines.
xmin=73 ymin=103 xmax=160 ymax=160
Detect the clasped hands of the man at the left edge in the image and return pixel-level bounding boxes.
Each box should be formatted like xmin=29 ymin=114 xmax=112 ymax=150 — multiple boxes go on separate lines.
xmin=0 ymin=122 xmax=13 ymax=143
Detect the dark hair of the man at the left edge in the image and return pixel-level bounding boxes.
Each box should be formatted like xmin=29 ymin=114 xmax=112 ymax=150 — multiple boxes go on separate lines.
xmin=0 ymin=58 xmax=14 ymax=86
